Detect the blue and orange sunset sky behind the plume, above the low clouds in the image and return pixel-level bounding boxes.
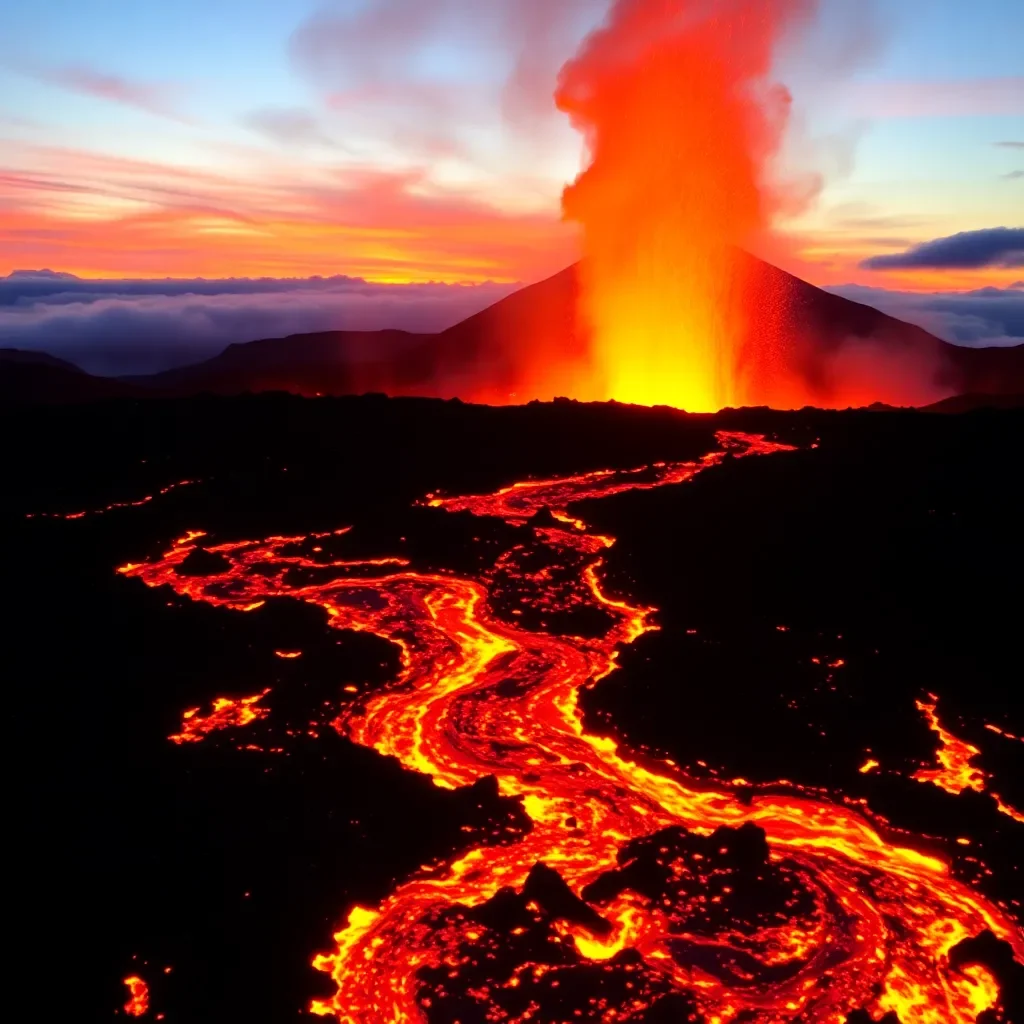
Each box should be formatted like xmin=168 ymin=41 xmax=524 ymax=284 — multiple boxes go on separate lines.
xmin=0 ymin=0 xmax=1024 ymax=366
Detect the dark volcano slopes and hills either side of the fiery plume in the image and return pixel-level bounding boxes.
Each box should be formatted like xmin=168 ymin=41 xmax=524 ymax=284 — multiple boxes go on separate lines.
xmin=9 ymin=256 xmax=1024 ymax=408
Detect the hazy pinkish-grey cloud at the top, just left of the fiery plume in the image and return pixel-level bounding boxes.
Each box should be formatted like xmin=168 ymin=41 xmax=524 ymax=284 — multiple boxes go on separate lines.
xmin=291 ymin=0 xmax=606 ymax=163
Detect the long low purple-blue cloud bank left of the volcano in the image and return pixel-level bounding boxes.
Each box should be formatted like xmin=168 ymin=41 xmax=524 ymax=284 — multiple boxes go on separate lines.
xmin=0 ymin=270 xmax=516 ymax=376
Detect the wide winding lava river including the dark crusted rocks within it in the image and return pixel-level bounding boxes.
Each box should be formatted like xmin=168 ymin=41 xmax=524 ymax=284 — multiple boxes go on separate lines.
xmin=119 ymin=432 xmax=1024 ymax=1024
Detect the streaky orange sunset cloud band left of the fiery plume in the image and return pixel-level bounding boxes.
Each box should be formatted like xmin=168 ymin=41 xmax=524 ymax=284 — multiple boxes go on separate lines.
xmin=0 ymin=147 xmax=575 ymax=282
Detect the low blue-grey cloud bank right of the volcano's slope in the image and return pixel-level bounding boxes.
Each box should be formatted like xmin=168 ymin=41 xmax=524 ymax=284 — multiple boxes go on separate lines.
xmin=827 ymin=281 xmax=1024 ymax=348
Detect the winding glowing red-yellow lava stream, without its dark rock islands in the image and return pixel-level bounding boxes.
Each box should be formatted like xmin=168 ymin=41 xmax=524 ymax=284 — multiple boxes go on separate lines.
xmin=119 ymin=433 xmax=1024 ymax=1024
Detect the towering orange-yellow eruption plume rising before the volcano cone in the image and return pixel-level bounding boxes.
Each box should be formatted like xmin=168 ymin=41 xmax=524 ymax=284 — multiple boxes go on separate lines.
xmin=556 ymin=0 xmax=813 ymax=412
